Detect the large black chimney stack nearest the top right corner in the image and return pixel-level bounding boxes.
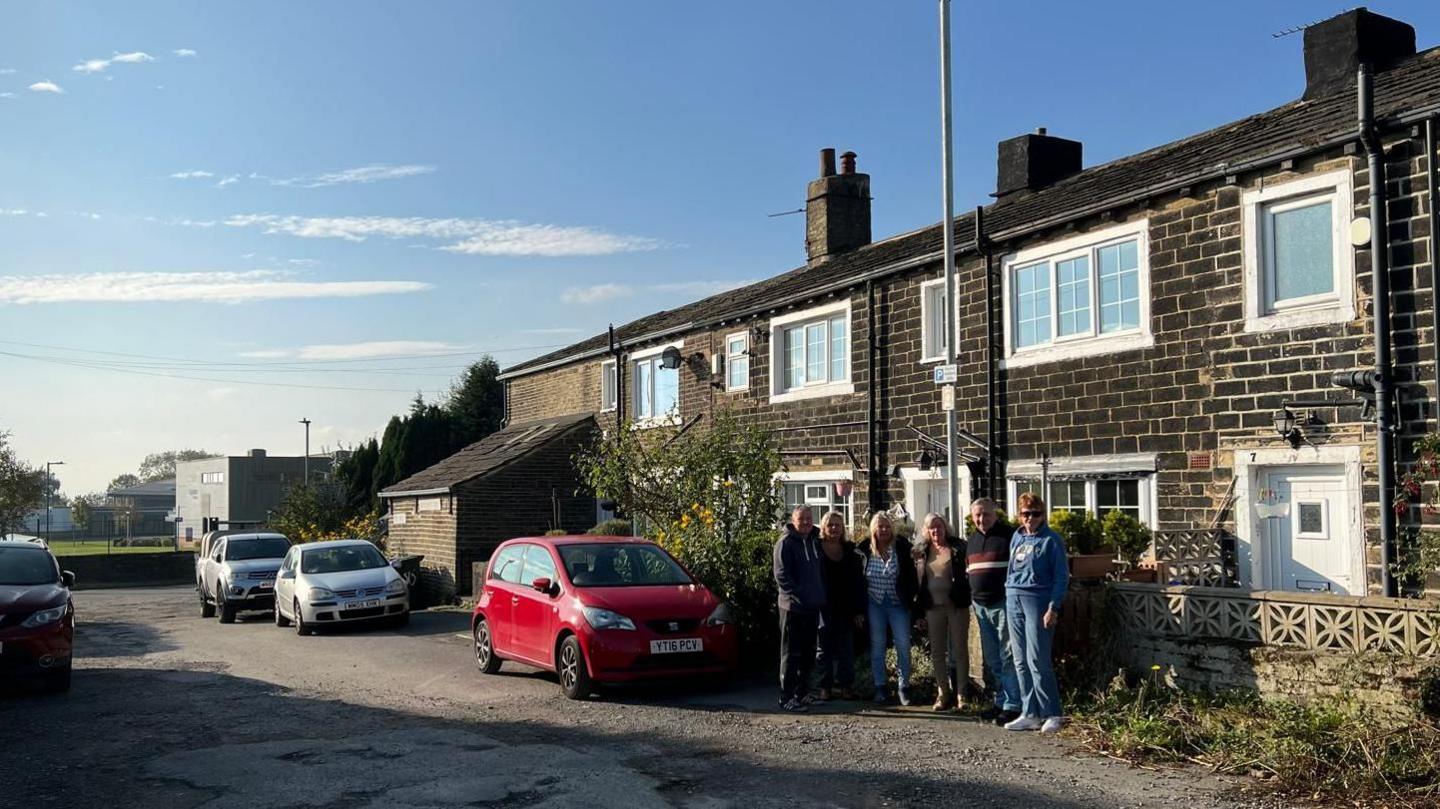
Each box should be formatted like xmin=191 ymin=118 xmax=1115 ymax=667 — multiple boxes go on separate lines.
xmin=1305 ymin=9 xmax=1416 ymax=99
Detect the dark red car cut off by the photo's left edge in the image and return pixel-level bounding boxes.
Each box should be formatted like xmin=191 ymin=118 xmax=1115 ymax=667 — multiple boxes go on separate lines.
xmin=0 ymin=540 xmax=75 ymax=691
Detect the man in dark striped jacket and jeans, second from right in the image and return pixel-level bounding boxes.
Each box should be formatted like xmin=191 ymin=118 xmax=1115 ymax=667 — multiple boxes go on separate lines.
xmin=965 ymin=497 xmax=1020 ymax=726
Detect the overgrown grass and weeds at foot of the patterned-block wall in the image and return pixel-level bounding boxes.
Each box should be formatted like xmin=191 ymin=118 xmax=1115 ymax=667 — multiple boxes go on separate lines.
xmin=1070 ymin=682 xmax=1440 ymax=808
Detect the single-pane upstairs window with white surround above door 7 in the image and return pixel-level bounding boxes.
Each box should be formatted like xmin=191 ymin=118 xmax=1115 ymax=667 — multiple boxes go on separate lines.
xmin=1241 ymin=170 xmax=1355 ymax=331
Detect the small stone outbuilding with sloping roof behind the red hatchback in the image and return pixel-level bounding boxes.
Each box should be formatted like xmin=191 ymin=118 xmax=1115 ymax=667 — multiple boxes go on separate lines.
xmin=380 ymin=413 xmax=599 ymax=600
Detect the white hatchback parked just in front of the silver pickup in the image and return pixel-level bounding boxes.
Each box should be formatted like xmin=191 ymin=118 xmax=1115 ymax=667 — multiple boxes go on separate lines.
xmin=275 ymin=540 xmax=410 ymax=635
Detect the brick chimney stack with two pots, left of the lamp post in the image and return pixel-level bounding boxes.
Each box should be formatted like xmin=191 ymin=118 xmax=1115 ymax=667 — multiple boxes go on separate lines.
xmin=805 ymin=148 xmax=870 ymax=266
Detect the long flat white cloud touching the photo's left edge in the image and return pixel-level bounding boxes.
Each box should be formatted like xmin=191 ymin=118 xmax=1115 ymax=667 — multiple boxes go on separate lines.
xmin=0 ymin=269 xmax=432 ymax=304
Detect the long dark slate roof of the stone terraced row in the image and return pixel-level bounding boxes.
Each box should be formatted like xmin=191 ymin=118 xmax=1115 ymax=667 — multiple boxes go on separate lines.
xmin=501 ymin=48 xmax=1440 ymax=379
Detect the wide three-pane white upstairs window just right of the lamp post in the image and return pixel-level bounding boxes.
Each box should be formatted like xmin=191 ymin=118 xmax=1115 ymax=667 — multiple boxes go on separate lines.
xmin=1002 ymin=219 xmax=1155 ymax=367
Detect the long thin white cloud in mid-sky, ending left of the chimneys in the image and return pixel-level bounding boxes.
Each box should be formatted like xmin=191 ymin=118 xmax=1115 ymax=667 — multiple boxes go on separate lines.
xmin=225 ymin=213 xmax=662 ymax=256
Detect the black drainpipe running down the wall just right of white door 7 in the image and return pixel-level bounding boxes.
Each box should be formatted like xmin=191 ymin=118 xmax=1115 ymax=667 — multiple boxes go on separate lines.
xmin=1358 ymin=65 xmax=1397 ymax=597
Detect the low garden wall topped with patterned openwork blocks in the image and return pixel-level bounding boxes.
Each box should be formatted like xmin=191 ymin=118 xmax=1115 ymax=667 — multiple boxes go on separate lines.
xmin=1106 ymin=583 xmax=1440 ymax=710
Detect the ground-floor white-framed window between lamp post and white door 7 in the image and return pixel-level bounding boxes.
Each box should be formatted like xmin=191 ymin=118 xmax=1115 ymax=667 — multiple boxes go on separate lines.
xmin=1005 ymin=453 xmax=1159 ymax=528
